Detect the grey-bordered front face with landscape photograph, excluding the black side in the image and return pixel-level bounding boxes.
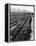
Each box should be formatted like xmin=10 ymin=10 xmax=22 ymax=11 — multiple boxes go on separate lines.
xmin=6 ymin=4 xmax=35 ymax=42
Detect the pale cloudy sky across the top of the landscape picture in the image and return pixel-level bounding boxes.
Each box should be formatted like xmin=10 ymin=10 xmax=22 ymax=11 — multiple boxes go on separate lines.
xmin=11 ymin=5 xmax=33 ymax=12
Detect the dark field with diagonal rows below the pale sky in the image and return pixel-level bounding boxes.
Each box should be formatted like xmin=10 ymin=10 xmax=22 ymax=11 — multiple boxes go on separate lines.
xmin=10 ymin=12 xmax=32 ymax=41
